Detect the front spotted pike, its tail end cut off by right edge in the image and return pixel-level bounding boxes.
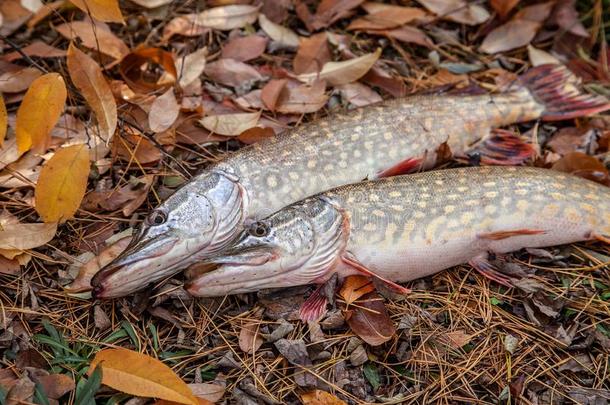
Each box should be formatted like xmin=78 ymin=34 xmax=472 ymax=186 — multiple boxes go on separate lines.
xmin=187 ymin=166 xmax=610 ymax=319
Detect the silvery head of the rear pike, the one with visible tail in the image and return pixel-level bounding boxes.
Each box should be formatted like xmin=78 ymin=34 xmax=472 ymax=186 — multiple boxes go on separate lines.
xmin=91 ymin=171 xmax=247 ymax=298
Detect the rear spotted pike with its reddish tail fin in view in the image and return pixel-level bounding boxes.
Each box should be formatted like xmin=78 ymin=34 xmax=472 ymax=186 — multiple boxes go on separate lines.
xmin=92 ymin=65 xmax=610 ymax=298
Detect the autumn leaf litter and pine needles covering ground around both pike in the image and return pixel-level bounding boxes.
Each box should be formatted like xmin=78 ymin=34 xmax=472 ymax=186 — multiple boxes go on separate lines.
xmin=0 ymin=0 xmax=610 ymax=404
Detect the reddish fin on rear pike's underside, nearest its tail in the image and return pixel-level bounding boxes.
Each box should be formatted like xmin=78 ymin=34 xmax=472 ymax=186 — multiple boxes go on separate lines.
xmin=466 ymin=129 xmax=536 ymax=166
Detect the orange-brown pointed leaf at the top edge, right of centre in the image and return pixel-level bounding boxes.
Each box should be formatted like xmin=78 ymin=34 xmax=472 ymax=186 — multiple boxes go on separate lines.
xmin=347 ymin=2 xmax=427 ymax=30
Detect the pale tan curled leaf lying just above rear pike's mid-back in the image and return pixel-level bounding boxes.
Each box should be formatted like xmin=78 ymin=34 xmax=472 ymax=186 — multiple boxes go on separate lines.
xmin=297 ymin=48 xmax=381 ymax=86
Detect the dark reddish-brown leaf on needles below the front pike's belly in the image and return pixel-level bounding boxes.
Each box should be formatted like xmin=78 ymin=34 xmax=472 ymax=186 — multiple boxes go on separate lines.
xmin=344 ymin=292 xmax=396 ymax=346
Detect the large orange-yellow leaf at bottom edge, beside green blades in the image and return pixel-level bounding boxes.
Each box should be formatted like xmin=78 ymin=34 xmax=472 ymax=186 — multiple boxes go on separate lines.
xmin=89 ymin=349 xmax=199 ymax=405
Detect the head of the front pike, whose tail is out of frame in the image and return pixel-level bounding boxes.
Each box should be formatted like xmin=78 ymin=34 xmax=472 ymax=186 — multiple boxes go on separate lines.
xmin=186 ymin=197 xmax=347 ymax=297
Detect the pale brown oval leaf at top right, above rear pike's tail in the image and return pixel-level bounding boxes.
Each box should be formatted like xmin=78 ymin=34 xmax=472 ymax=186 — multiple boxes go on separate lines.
xmin=479 ymin=19 xmax=542 ymax=54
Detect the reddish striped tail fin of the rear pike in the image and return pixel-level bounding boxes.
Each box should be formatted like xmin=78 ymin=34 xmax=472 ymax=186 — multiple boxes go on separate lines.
xmin=517 ymin=64 xmax=610 ymax=121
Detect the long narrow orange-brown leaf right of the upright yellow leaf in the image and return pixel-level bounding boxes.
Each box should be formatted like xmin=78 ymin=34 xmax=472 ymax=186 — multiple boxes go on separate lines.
xmin=68 ymin=44 xmax=117 ymax=141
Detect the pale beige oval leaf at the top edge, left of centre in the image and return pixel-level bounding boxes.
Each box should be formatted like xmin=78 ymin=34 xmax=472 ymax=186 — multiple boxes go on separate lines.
xmin=197 ymin=4 xmax=259 ymax=31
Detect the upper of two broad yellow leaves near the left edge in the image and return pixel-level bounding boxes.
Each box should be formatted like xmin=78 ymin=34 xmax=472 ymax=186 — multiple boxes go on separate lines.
xmin=15 ymin=73 xmax=68 ymax=153
